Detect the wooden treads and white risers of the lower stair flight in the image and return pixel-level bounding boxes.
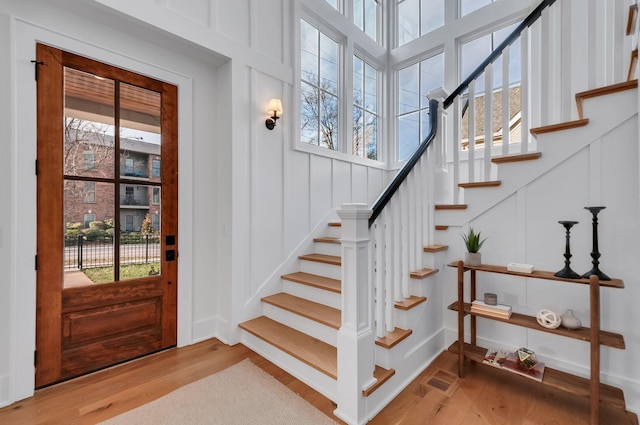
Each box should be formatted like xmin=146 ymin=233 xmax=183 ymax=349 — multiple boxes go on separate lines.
xmin=239 ymin=222 xmax=447 ymax=401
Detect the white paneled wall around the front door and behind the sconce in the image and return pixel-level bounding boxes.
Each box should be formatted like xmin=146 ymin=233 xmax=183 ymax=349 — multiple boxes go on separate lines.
xmin=0 ymin=0 xmax=389 ymax=407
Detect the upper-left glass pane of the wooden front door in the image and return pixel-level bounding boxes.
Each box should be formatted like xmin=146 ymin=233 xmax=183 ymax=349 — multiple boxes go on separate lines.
xmin=64 ymin=68 xmax=115 ymax=178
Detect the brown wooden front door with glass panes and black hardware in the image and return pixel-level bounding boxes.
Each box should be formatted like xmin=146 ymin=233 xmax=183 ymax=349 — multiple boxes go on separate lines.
xmin=35 ymin=44 xmax=178 ymax=387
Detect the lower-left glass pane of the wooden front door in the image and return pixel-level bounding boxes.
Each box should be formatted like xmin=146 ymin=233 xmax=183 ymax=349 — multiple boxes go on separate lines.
xmin=63 ymin=179 xmax=115 ymax=288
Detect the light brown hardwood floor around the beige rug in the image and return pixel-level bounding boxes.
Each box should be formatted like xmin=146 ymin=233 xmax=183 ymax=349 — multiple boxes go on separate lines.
xmin=0 ymin=339 xmax=638 ymax=425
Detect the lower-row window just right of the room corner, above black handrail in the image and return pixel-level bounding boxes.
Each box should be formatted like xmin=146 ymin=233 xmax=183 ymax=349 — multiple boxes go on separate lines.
xmin=398 ymin=53 xmax=444 ymax=161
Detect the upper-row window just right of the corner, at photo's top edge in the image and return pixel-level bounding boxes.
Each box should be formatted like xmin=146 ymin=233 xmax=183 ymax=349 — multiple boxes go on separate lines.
xmin=396 ymin=0 xmax=444 ymax=46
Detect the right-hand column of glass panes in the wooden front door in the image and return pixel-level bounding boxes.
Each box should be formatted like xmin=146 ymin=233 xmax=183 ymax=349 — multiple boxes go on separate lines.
xmin=119 ymin=83 xmax=162 ymax=280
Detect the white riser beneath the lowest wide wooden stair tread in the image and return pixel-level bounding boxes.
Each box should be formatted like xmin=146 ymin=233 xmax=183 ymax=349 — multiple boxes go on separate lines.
xmin=242 ymin=331 xmax=338 ymax=402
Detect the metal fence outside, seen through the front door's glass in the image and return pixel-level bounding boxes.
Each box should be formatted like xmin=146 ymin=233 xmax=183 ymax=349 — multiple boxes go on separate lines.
xmin=64 ymin=233 xmax=160 ymax=270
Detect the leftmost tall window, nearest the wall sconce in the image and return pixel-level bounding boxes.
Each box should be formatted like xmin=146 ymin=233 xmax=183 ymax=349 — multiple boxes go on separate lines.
xmin=300 ymin=19 xmax=340 ymax=150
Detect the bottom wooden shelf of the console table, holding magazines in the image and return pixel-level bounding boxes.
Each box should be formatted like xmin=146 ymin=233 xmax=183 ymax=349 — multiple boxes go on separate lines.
xmin=448 ymin=341 xmax=626 ymax=410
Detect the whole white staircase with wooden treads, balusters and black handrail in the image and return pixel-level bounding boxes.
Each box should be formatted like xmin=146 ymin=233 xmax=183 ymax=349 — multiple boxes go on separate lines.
xmin=239 ymin=1 xmax=638 ymax=424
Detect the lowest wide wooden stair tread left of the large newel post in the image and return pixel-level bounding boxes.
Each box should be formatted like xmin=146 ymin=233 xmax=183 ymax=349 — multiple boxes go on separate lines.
xmin=238 ymin=316 xmax=338 ymax=379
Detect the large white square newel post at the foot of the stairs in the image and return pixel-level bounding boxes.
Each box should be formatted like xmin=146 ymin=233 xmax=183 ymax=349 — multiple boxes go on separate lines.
xmin=334 ymin=204 xmax=375 ymax=425
